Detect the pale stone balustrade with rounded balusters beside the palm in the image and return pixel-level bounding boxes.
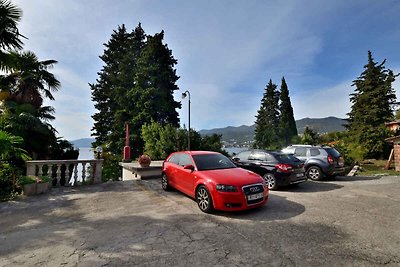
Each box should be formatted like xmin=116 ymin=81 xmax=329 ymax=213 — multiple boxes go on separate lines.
xmin=26 ymin=159 xmax=103 ymax=186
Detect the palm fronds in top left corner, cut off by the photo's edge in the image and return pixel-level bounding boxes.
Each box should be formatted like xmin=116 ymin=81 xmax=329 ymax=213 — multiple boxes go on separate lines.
xmin=0 ymin=0 xmax=25 ymax=50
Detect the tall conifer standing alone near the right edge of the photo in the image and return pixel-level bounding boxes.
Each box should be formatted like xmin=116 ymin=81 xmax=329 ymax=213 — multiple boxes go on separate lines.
xmin=347 ymin=51 xmax=396 ymax=158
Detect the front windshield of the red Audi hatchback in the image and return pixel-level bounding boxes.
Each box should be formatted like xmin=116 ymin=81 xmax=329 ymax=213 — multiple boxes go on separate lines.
xmin=193 ymin=154 xmax=236 ymax=171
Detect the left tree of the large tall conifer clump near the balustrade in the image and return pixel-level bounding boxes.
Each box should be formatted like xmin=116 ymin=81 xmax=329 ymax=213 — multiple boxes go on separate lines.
xmin=90 ymin=25 xmax=135 ymax=152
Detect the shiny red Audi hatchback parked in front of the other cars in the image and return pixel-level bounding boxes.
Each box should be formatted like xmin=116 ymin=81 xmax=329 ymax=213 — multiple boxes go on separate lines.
xmin=161 ymin=151 xmax=268 ymax=213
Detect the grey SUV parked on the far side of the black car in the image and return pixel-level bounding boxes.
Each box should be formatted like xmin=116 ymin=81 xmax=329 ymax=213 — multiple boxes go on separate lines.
xmin=282 ymin=145 xmax=345 ymax=181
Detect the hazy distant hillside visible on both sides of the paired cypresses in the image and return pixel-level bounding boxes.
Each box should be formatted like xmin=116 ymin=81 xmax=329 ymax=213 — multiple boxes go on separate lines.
xmin=199 ymin=117 xmax=346 ymax=146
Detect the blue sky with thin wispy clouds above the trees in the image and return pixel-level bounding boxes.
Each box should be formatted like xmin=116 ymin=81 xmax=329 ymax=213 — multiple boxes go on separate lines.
xmin=11 ymin=0 xmax=400 ymax=141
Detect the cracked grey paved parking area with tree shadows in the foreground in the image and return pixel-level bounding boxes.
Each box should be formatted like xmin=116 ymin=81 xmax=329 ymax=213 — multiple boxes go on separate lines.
xmin=0 ymin=177 xmax=400 ymax=266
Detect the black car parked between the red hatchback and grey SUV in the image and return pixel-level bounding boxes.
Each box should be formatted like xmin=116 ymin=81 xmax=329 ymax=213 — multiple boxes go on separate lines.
xmin=232 ymin=149 xmax=307 ymax=190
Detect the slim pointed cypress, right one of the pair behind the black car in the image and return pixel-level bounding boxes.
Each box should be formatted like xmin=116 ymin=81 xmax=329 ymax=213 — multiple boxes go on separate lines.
xmin=279 ymin=77 xmax=297 ymax=145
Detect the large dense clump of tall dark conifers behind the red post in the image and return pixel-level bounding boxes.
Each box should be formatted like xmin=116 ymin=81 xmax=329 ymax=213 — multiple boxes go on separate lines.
xmin=90 ymin=24 xmax=180 ymax=155
